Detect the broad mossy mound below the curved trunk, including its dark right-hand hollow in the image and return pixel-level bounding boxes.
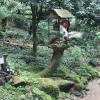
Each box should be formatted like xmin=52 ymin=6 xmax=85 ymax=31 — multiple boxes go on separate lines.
xmin=29 ymin=78 xmax=76 ymax=99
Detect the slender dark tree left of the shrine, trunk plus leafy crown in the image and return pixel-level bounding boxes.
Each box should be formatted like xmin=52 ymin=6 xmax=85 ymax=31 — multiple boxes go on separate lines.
xmin=20 ymin=0 xmax=48 ymax=57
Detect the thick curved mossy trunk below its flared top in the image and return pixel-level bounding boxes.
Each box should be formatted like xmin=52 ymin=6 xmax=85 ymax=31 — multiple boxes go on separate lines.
xmin=40 ymin=42 xmax=65 ymax=77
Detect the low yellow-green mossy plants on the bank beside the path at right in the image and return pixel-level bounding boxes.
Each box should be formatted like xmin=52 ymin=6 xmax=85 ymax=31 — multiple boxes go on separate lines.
xmin=64 ymin=65 xmax=99 ymax=85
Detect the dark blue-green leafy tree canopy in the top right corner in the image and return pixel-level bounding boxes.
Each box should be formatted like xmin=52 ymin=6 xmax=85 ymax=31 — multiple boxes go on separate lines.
xmin=64 ymin=0 xmax=100 ymax=30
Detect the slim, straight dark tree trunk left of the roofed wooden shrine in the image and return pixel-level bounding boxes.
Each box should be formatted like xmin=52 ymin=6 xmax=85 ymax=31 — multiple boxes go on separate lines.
xmin=31 ymin=4 xmax=37 ymax=57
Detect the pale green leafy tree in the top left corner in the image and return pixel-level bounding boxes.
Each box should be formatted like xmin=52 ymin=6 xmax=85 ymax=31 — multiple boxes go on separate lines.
xmin=0 ymin=0 xmax=23 ymax=32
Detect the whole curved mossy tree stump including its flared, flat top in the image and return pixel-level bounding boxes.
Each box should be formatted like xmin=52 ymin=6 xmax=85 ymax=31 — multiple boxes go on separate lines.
xmin=39 ymin=41 xmax=69 ymax=77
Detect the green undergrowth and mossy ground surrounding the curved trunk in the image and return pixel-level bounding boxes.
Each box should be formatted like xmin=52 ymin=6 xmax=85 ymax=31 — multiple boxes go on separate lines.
xmin=0 ymin=27 xmax=99 ymax=100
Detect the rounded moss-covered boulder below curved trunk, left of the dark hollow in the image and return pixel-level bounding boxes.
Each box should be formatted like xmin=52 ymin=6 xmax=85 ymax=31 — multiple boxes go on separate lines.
xmin=27 ymin=78 xmax=59 ymax=98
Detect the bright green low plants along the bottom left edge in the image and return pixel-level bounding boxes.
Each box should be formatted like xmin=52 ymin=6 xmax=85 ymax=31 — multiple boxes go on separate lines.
xmin=0 ymin=84 xmax=52 ymax=100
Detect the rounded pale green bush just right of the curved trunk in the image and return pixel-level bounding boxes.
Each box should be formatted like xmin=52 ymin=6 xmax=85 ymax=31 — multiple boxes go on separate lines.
xmin=60 ymin=46 xmax=86 ymax=70
